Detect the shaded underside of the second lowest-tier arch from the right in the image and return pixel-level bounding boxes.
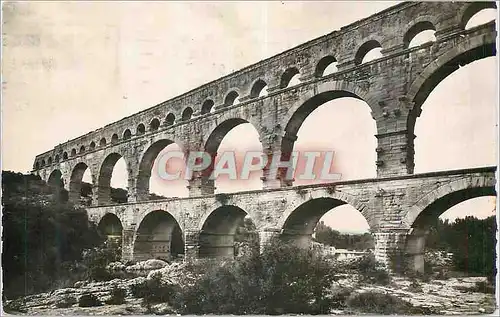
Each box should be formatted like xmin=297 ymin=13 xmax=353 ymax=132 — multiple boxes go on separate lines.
xmin=280 ymin=197 xmax=370 ymax=248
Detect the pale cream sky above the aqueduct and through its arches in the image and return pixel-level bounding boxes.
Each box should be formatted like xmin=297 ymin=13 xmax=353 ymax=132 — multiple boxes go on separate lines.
xmin=1 ymin=1 xmax=498 ymax=232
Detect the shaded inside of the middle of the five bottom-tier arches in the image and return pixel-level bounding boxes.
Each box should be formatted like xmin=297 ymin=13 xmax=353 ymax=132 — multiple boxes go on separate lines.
xmin=198 ymin=205 xmax=254 ymax=258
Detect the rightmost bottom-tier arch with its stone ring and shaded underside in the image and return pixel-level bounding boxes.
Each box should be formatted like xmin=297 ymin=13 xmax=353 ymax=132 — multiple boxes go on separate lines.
xmin=404 ymin=178 xmax=496 ymax=272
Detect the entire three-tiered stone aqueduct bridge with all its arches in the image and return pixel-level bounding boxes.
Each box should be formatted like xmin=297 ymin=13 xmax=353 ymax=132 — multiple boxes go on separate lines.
xmin=33 ymin=2 xmax=496 ymax=269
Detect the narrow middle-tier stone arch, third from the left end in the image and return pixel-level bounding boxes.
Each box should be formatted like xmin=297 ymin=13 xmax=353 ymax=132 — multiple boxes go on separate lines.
xmin=97 ymin=152 xmax=131 ymax=205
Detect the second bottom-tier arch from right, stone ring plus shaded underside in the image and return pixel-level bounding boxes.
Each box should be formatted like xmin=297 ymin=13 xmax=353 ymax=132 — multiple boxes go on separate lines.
xmin=278 ymin=191 xmax=376 ymax=247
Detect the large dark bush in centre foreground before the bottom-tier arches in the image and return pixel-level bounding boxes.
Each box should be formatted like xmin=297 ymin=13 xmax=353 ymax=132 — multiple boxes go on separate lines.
xmin=173 ymin=241 xmax=334 ymax=314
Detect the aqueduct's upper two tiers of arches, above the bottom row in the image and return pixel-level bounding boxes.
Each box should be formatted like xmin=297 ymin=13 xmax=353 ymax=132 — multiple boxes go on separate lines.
xmin=33 ymin=2 xmax=496 ymax=203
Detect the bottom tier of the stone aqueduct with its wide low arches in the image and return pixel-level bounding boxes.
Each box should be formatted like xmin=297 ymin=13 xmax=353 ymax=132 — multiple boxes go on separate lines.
xmin=89 ymin=167 xmax=496 ymax=268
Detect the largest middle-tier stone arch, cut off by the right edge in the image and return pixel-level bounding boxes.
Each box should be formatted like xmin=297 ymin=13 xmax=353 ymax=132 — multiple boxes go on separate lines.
xmin=406 ymin=33 xmax=496 ymax=135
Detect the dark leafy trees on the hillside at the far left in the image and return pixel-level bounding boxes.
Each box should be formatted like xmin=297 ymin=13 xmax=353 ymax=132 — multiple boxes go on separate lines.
xmin=2 ymin=171 xmax=103 ymax=298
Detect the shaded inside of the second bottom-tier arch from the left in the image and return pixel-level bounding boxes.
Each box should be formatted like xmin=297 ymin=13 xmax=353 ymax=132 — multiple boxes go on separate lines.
xmin=134 ymin=210 xmax=184 ymax=261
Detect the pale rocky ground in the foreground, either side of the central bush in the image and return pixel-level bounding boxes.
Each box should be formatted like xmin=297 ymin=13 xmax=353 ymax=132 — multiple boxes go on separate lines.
xmin=2 ymin=260 xmax=495 ymax=316
